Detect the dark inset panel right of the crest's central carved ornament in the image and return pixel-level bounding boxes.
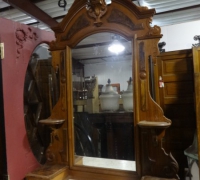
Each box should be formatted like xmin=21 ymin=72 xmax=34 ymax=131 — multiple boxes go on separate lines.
xmin=108 ymin=9 xmax=144 ymax=31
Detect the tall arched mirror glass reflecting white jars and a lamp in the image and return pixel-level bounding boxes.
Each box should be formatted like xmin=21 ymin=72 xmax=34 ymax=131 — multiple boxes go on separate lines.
xmin=72 ymin=33 xmax=135 ymax=171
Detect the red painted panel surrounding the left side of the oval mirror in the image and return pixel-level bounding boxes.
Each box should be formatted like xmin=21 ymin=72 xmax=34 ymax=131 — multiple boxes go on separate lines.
xmin=0 ymin=18 xmax=55 ymax=180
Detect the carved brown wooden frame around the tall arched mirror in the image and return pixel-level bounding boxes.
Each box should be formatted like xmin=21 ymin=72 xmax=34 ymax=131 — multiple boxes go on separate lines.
xmin=47 ymin=0 xmax=177 ymax=179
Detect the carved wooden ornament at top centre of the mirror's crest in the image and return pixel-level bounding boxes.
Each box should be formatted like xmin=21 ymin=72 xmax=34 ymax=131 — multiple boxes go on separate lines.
xmin=87 ymin=0 xmax=107 ymax=27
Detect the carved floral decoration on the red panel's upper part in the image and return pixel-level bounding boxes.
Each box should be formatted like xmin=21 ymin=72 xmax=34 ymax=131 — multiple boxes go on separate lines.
xmin=15 ymin=27 xmax=38 ymax=59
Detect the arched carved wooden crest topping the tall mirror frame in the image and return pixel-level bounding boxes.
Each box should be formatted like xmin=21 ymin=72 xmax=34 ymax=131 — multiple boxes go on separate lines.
xmin=50 ymin=0 xmax=162 ymax=50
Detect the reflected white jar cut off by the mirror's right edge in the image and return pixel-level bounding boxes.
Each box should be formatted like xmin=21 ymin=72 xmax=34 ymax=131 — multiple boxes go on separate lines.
xmin=122 ymin=77 xmax=133 ymax=112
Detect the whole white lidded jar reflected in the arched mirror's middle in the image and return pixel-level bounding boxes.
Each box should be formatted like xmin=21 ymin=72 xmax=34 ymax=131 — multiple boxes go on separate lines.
xmin=99 ymin=79 xmax=120 ymax=111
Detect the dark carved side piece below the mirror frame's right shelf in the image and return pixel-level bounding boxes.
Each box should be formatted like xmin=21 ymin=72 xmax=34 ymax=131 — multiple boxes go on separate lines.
xmin=140 ymin=124 xmax=179 ymax=180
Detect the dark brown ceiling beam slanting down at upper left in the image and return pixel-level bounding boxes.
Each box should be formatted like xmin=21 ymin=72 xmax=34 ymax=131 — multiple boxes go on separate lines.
xmin=3 ymin=0 xmax=58 ymax=28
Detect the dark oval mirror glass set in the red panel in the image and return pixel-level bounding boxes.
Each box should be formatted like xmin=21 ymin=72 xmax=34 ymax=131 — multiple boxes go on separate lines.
xmin=24 ymin=44 xmax=59 ymax=164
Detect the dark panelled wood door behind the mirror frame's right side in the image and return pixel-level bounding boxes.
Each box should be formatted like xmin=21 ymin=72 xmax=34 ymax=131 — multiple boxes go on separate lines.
xmin=158 ymin=50 xmax=196 ymax=179
